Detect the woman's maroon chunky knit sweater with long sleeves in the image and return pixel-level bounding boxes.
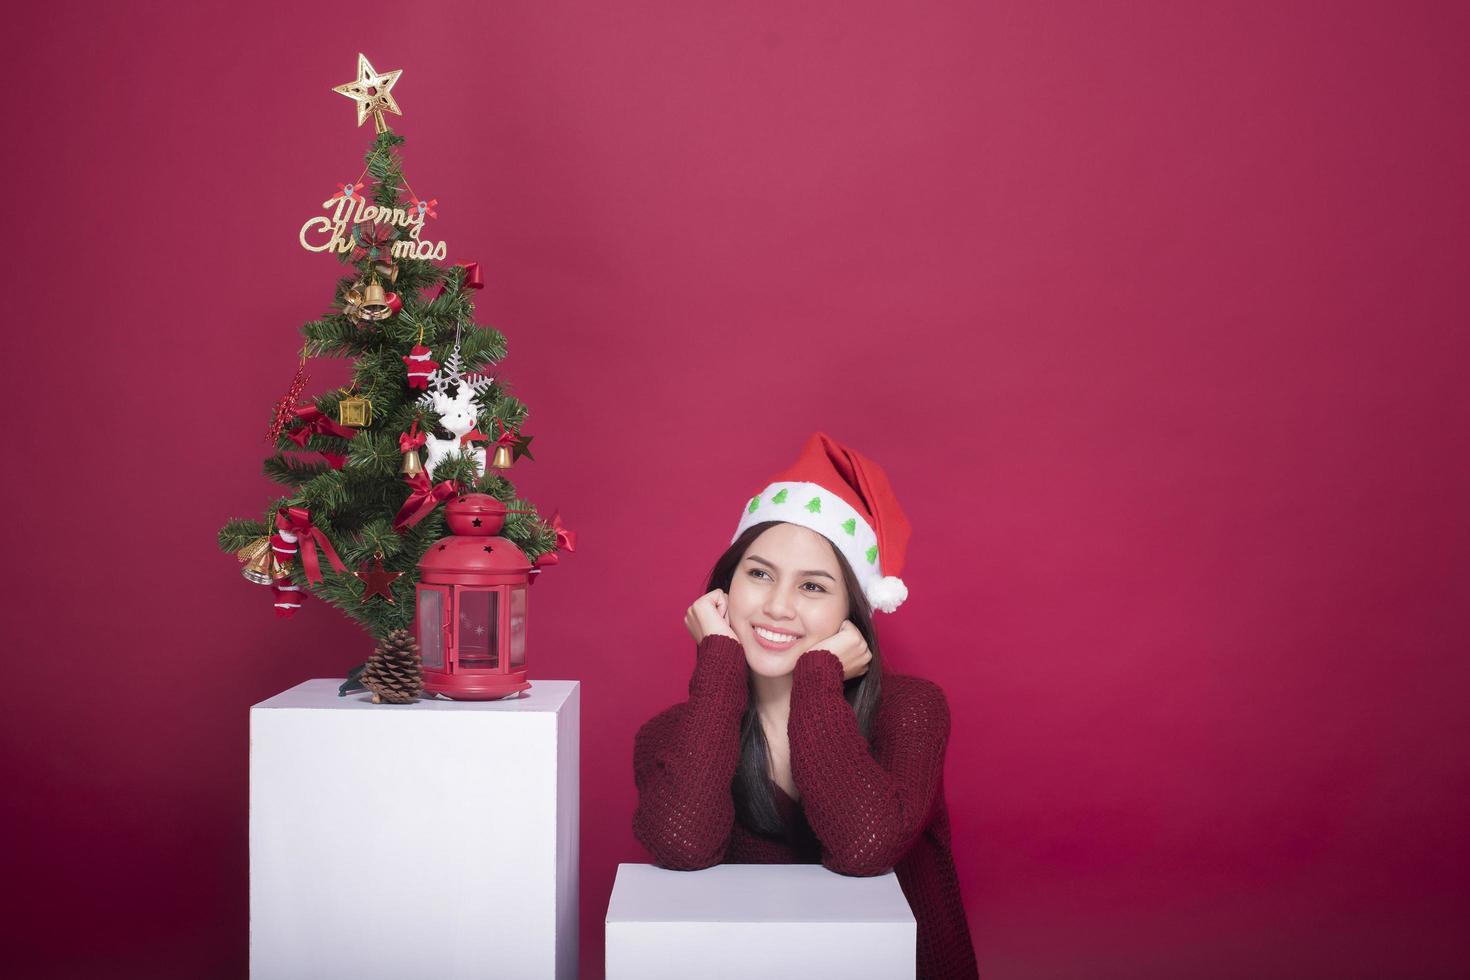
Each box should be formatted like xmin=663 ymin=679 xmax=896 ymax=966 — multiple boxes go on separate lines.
xmin=634 ymin=633 xmax=976 ymax=980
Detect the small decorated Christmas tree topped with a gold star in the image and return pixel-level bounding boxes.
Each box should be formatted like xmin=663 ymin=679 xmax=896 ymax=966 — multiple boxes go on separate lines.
xmin=219 ymin=59 xmax=564 ymax=669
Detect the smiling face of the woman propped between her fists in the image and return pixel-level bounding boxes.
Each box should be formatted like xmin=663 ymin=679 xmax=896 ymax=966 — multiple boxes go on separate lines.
xmin=729 ymin=525 xmax=848 ymax=677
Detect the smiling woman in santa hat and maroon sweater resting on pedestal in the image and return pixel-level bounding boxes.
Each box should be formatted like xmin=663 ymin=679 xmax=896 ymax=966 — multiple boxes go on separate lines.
xmin=634 ymin=432 xmax=976 ymax=977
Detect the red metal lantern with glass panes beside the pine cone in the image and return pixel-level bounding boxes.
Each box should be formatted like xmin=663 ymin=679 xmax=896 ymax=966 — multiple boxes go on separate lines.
xmin=415 ymin=494 xmax=531 ymax=701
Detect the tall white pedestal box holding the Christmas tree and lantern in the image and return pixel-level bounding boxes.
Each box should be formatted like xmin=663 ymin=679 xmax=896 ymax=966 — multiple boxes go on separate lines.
xmin=250 ymin=680 xmax=581 ymax=980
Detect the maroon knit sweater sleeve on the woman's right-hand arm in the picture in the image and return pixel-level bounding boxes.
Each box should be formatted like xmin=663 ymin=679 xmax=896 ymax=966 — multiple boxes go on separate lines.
xmin=786 ymin=649 xmax=950 ymax=876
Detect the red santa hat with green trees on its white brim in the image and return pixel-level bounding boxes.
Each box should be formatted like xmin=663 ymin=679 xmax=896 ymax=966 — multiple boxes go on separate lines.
xmin=731 ymin=432 xmax=910 ymax=613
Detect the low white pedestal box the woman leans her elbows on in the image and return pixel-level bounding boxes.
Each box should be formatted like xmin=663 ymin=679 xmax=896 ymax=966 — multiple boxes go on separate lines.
xmin=607 ymin=864 xmax=917 ymax=980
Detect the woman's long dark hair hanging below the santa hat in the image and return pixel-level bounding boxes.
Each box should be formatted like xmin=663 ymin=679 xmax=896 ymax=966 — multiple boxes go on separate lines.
xmin=704 ymin=520 xmax=883 ymax=837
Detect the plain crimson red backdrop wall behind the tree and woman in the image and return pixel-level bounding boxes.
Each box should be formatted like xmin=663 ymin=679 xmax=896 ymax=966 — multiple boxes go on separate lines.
xmin=0 ymin=0 xmax=1470 ymax=977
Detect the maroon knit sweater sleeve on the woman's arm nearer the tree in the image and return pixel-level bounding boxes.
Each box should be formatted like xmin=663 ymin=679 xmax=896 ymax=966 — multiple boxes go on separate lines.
xmin=634 ymin=633 xmax=747 ymax=871
